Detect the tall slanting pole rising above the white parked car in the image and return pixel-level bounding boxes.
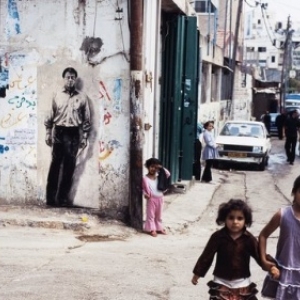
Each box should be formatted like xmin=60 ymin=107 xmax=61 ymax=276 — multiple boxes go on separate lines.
xmin=230 ymin=0 xmax=244 ymax=118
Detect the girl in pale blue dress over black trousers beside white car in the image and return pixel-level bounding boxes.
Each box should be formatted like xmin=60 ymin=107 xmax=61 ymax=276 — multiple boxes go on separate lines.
xmin=201 ymin=121 xmax=219 ymax=183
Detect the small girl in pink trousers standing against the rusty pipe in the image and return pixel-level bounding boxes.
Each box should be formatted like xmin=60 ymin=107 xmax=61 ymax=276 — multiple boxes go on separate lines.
xmin=143 ymin=158 xmax=170 ymax=237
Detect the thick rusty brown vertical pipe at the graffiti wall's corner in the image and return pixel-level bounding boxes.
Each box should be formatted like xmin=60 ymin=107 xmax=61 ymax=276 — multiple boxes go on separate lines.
xmin=129 ymin=0 xmax=144 ymax=230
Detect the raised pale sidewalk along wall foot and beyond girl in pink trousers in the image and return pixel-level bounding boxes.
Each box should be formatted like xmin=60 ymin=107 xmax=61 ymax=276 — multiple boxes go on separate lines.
xmin=0 ymin=171 xmax=221 ymax=237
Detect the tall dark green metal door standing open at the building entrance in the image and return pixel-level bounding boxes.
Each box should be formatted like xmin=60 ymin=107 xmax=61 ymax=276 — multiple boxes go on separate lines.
xmin=159 ymin=15 xmax=199 ymax=183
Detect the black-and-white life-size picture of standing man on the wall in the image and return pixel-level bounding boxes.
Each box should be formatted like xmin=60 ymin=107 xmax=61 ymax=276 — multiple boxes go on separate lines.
xmin=44 ymin=68 xmax=91 ymax=206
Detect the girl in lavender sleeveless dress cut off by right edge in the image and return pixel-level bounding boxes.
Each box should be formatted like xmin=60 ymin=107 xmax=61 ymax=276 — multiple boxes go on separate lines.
xmin=259 ymin=176 xmax=300 ymax=300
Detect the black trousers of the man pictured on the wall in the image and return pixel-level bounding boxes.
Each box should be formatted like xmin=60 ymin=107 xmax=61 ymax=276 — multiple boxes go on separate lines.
xmin=46 ymin=126 xmax=79 ymax=206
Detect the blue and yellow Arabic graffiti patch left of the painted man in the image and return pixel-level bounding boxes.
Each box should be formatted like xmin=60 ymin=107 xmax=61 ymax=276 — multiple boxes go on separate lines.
xmin=0 ymin=53 xmax=37 ymax=167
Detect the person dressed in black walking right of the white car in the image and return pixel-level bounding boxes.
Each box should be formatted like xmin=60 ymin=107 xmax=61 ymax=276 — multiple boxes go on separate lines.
xmin=284 ymin=109 xmax=300 ymax=165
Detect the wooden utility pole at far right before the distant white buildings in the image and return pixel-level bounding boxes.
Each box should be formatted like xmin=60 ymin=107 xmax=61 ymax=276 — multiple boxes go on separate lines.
xmin=279 ymin=16 xmax=292 ymax=111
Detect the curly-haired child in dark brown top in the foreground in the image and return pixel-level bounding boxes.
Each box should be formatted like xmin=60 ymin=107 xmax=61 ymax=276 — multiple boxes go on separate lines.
xmin=192 ymin=199 xmax=260 ymax=300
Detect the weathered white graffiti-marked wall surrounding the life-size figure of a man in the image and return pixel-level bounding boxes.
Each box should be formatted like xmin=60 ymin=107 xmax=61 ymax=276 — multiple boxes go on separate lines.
xmin=0 ymin=0 xmax=129 ymax=216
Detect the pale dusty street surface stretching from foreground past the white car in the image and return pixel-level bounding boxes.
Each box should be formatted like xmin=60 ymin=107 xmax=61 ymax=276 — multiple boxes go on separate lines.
xmin=0 ymin=137 xmax=300 ymax=300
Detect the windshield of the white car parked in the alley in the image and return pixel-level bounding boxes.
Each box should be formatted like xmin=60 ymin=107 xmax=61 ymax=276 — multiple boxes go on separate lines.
xmin=220 ymin=123 xmax=264 ymax=138
